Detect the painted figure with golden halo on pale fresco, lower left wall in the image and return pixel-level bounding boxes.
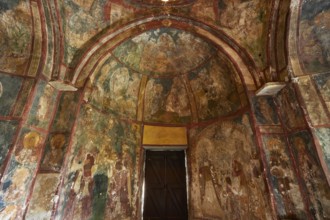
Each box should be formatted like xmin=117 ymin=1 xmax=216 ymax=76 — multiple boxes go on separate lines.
xmin=15 ymin=131 xmax=41 ymax=164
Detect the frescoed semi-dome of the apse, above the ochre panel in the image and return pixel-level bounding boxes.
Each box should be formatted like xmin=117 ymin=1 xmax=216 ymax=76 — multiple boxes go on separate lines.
xmin=85 ymin=27 xmax=242 ymax=124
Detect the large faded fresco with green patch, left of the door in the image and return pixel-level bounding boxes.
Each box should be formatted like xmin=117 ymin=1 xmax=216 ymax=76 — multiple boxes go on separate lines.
xmin=56 ymin=105 xmax=140 ymax=219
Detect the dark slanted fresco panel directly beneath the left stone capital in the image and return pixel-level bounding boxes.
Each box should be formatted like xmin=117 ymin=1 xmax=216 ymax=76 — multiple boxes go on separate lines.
xmin=51 ymin=92 xmax=80 ymax=132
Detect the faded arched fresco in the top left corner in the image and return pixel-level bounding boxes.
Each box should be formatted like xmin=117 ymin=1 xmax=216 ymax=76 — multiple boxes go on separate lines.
xmin=0 ymin=0 xmax=32 ymax=75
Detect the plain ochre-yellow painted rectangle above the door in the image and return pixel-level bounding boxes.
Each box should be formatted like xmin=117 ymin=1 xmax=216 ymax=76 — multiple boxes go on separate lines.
xmin=142 ymin=125 xmax=188 ymax=145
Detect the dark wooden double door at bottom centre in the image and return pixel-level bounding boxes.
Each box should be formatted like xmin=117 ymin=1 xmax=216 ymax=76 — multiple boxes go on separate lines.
xmin=143 ymin=150 xmax=188 ymax=220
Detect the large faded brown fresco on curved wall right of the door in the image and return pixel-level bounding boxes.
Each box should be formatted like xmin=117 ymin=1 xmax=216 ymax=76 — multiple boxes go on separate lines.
xmin=188 ymin=115 xmax=272 ymax=220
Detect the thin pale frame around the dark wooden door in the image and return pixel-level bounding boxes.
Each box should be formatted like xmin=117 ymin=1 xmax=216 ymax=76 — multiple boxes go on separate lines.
xmin=140 ymin=145 xmax=189 ymax=220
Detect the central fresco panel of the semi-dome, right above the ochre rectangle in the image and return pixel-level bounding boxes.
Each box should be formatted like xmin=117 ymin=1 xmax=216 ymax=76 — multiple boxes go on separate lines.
xmin=144 ymin=77 xmax=191 ymax=123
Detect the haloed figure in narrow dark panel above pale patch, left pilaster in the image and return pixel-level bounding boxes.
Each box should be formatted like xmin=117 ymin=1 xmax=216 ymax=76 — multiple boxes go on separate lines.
xmin=43 ymin=134 xmax=65 ymax=171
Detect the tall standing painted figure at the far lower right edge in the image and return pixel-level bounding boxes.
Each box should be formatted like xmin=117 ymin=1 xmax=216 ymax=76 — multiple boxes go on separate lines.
xmin=293 ymin=137 xmax=330 ymax=219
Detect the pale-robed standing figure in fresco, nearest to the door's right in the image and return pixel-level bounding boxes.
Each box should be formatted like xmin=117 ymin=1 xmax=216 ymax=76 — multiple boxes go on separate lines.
xmin=197 ymin=139 xmax=223 ymax=218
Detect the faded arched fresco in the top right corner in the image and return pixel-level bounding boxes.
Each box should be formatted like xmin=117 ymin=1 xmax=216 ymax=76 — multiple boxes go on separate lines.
xmin=299 ymin=0 xmax=330 ymax=74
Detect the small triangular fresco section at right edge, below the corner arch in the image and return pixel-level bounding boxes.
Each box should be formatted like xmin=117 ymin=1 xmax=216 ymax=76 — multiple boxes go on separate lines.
xmin=313 ymin=73 xmax=330 ymax=111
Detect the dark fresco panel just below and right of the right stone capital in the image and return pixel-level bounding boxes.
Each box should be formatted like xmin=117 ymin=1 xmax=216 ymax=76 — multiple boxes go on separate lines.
xmin=275 ymin=86 xmax=306 ymax=130
